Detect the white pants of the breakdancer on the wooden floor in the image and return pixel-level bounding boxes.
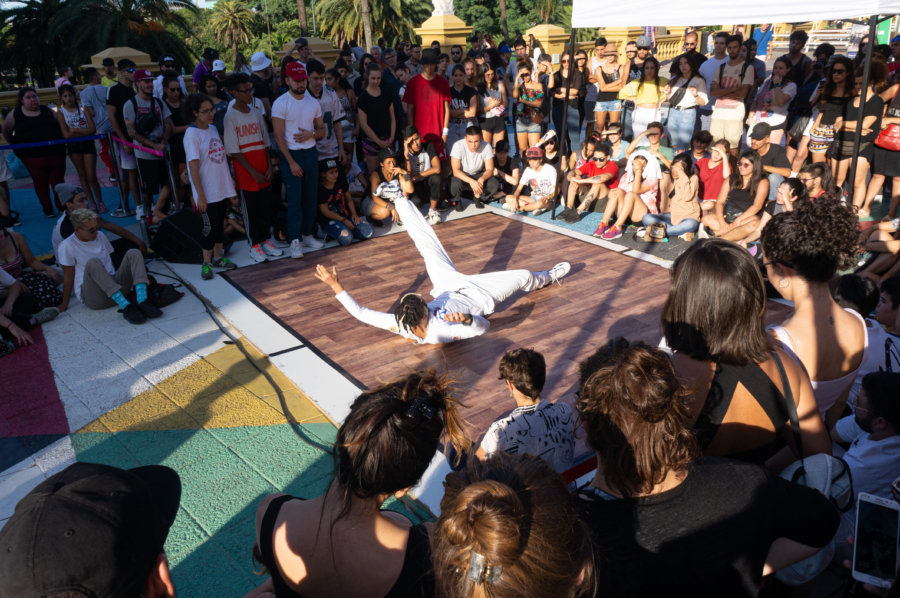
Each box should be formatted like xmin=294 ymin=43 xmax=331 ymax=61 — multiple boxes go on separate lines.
xmin=395 ymin=197 xmax=550 ymax=316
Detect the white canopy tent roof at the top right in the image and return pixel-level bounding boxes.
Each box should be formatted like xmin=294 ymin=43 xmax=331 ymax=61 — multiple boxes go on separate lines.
xmin=572 ymin=0 xmax=900 ymax=27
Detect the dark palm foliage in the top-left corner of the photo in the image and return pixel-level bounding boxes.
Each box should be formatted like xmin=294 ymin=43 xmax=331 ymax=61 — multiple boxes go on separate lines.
xmin=0 ymin=0 xmax=68 ymax=86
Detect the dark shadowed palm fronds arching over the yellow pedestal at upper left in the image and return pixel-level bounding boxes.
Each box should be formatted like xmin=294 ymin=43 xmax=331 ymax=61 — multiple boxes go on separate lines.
xmin=51 ymin=0 xmax=198 ymax=71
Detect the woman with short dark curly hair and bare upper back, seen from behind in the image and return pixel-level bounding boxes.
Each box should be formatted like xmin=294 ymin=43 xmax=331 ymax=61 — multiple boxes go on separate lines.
xmin=762 ymin=196 xmax=868 ymax=428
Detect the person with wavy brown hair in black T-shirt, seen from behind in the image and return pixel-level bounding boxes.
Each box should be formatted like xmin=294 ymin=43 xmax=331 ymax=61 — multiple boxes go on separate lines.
xmin=576 ymin=342 xmax=839 ymax=598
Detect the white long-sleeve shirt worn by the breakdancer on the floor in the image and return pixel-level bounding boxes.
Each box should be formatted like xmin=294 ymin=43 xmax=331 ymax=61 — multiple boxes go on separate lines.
xmin=335 ymin=291 xmax=491 ymax=345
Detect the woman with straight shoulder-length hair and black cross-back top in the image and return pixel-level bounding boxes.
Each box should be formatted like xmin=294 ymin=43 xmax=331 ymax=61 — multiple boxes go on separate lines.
xmin=661 ymin=239 xmax=831 ymax=471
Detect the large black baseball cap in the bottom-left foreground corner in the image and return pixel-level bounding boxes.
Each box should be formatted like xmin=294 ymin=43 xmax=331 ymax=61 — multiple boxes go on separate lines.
xmin=0 ymin=463 xmax=181 ymax=597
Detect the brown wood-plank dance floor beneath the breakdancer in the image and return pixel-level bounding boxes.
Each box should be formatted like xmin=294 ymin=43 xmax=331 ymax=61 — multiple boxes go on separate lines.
xmin=227 ymin=214 xmax=684 ymax=438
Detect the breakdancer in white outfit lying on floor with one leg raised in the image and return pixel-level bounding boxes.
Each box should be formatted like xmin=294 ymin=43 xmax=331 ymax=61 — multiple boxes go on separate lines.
xmin=316 ymin=190 xmax=571 ymax=344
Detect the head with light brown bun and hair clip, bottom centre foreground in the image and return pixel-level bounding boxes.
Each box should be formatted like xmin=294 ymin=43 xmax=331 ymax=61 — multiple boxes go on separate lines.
xmin=431 ymin=452 xmax=594 ymax=598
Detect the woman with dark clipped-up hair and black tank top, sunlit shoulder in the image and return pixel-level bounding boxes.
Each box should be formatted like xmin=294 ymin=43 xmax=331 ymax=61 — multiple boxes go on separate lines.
xmin=248 ymin=370 xmax=471 ymax=598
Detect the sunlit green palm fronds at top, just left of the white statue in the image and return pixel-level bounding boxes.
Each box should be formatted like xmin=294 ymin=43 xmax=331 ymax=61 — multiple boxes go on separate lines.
xmin=316 ymin=0 xmax=432 ymax=47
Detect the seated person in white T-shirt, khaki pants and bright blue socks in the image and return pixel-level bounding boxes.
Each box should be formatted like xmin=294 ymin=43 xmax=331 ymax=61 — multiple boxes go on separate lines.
xmin=58 ymin=208 xmax=162 ymax=324
